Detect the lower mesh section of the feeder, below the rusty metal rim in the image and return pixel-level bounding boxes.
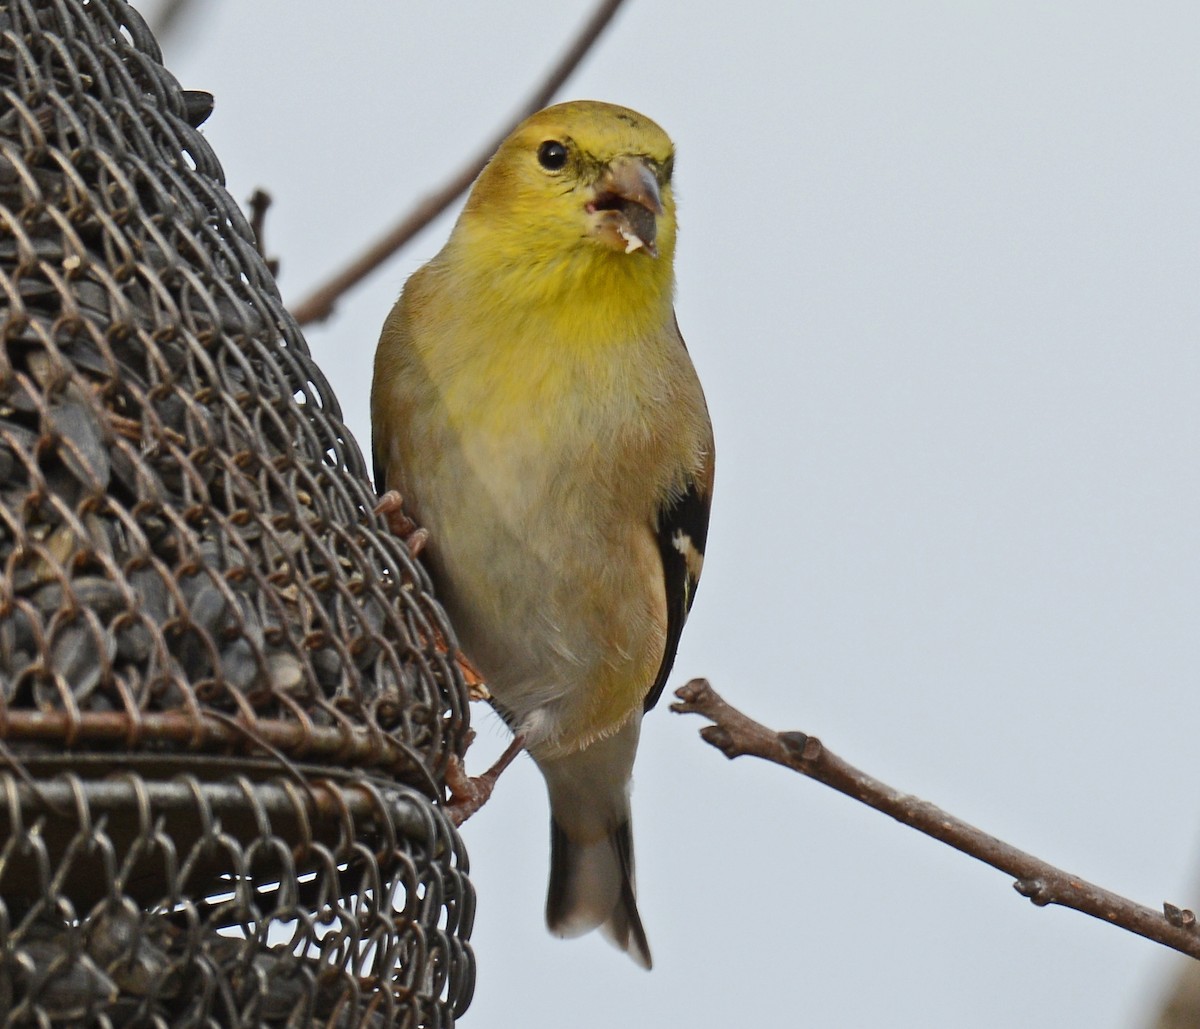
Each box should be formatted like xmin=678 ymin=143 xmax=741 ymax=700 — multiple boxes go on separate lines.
xmin=0 ymin=774 xmax=472 ymax=1029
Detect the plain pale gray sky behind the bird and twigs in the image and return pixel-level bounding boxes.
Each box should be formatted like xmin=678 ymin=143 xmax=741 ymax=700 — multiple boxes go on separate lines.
xmin=145 ymin=0 xmax=1200 ymax=1029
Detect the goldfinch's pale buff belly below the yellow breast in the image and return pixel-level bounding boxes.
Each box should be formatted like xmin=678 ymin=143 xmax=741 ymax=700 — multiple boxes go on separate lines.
xmin=420 ymin=438 xmax=666 ymax=754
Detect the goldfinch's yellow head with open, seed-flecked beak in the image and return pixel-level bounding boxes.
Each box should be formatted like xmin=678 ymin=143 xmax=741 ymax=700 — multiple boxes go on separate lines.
xmin=460 ymin=101 xmax=676 ymax=301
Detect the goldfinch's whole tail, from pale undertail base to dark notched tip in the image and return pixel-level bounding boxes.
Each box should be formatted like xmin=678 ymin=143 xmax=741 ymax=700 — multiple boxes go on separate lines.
xmin=538 ymin=715 xmax=650 ymax=968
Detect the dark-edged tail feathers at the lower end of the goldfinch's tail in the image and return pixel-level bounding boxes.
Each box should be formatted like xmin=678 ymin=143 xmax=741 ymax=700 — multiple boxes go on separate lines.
xmin=546 ymin=818 xmax=652 ymax=969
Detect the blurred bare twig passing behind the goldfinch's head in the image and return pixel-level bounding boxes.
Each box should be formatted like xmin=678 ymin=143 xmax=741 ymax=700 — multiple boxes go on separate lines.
xmin=292 ymin=0 xmax=623 ymax=325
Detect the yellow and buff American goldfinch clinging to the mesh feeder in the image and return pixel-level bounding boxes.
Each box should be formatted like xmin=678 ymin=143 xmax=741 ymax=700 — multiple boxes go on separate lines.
xmin=371 ymin=101 xmax=713 ymax=968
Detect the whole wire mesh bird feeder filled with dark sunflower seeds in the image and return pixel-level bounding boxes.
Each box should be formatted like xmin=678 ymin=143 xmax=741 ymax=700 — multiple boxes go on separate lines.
xmin=0 ymin=0 xmax=474 ymax=1029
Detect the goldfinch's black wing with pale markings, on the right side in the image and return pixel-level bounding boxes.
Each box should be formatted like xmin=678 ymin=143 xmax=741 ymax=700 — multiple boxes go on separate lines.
xmin=642 ymin=465 xmax=712 ymax=711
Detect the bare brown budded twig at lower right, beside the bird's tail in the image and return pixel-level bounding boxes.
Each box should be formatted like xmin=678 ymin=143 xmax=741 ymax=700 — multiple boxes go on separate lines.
xmin=671 ymin=679 xmax=1200 ymax=958
